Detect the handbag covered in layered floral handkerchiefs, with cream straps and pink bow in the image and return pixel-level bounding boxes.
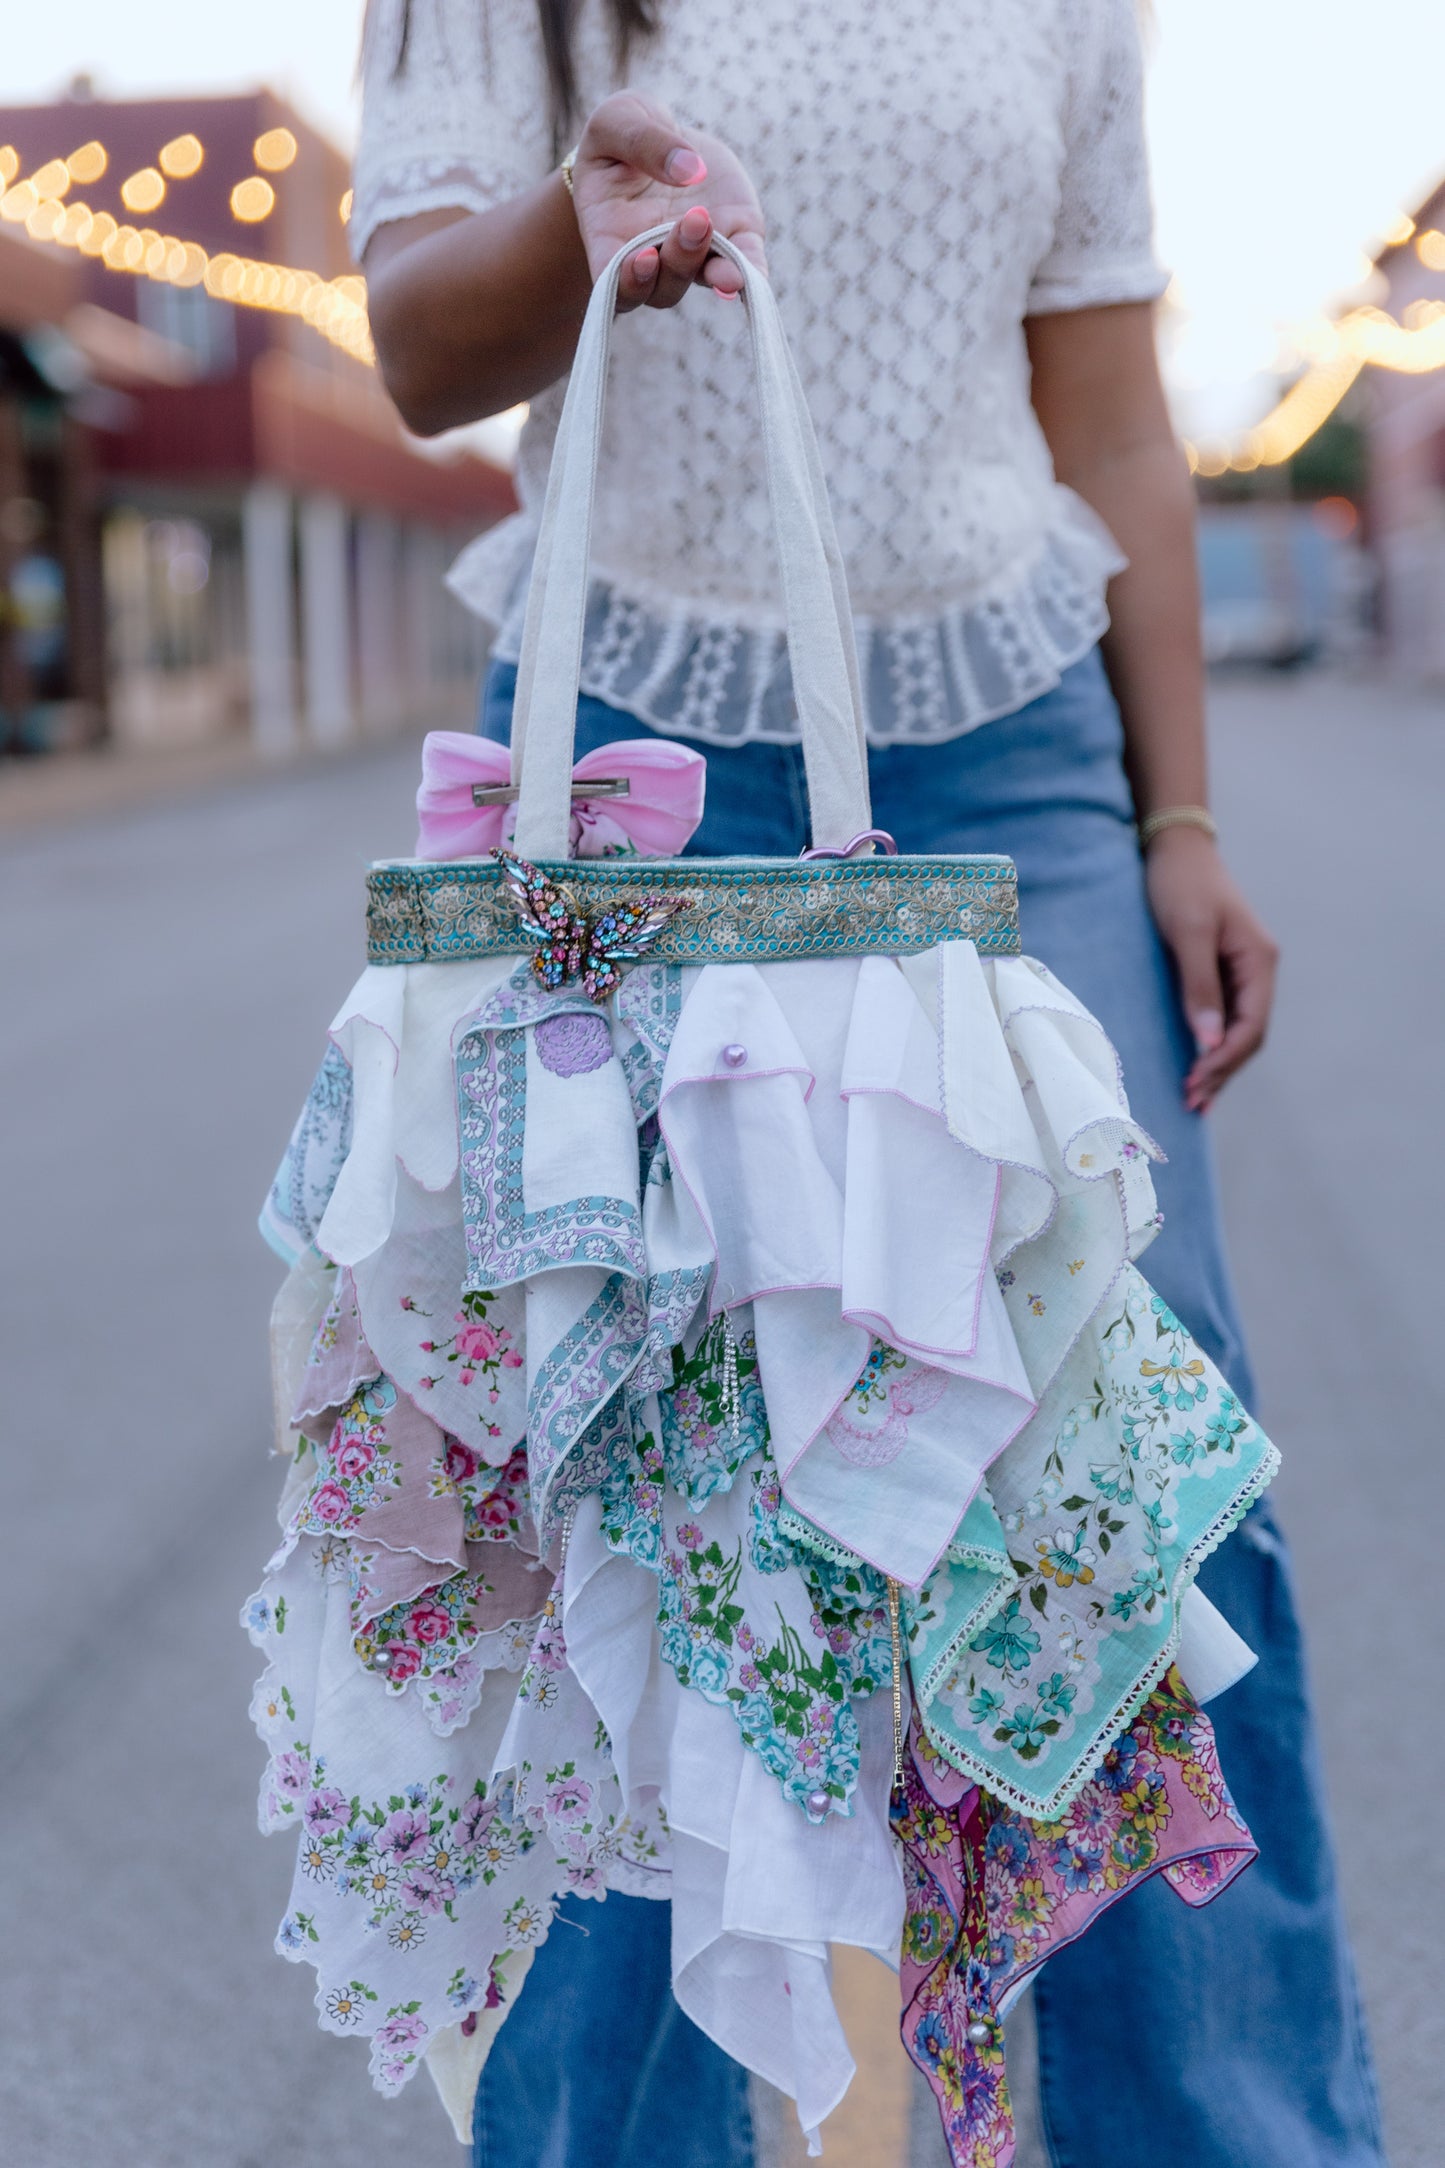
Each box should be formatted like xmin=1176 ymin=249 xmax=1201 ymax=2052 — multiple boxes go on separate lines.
xmin=247 ymin=228 xmax=1276 ymax=2161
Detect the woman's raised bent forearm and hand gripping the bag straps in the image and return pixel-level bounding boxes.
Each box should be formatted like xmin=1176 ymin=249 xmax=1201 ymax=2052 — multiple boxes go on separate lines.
xmin=366 ymin=91 xmax=765 ymax=436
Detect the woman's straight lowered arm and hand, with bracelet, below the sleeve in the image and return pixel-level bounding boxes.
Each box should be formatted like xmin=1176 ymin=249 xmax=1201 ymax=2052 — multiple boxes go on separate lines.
xmin=1025 ymin=304 xmax=1276 ymax=1112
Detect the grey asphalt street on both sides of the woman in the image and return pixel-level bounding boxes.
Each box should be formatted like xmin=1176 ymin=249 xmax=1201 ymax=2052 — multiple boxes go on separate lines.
xmin=0 ymin=679 xmax=1445 ymax=2168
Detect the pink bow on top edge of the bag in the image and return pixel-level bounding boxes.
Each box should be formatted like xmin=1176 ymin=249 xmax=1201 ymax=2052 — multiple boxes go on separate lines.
xmin=416 ymin=731 xmax=708 ymax=859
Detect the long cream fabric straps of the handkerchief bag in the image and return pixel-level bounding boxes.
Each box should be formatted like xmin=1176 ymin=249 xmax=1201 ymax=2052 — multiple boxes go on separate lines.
xmin=511 ymin=225 xmax=871 ymax=859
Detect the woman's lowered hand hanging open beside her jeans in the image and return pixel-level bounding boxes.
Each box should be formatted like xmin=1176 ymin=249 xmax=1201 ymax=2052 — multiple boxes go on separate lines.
xmin=1144 ymin=826 xmax=1278 ymax=1114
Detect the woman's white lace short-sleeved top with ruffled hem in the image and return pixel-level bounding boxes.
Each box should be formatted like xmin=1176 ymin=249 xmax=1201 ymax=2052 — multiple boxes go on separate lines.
xmin=351 ymin=0 xmax=1163 ymax=744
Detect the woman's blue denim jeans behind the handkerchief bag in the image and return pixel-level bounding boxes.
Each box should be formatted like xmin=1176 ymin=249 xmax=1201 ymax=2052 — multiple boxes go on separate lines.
xmin=474 ymin=653 xmax=1384 ymax=2168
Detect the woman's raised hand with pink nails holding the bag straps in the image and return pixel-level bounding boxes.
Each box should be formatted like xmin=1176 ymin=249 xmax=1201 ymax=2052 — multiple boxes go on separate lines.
xmin=572 ymin=91 xmax=767 ymax=310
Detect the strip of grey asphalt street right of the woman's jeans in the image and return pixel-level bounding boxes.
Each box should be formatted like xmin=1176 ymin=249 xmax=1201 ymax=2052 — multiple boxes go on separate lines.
xmin=1218 ymin=679 xmax=1445 ymax=2168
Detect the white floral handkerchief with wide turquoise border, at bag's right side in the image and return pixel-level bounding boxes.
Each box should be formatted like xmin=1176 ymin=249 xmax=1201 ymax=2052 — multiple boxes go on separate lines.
xmin=896 ymin=1270 xmax=1278 ymax=1819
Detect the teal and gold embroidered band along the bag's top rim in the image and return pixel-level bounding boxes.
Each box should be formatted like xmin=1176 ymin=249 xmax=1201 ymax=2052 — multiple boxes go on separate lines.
xmin=366 ymin=856 xmax=1020 ymax=965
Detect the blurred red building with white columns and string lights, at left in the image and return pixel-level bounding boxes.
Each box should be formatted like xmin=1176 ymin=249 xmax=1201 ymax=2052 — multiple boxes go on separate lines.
xmin=0 ymin=91 xmax=513 ymax=752
